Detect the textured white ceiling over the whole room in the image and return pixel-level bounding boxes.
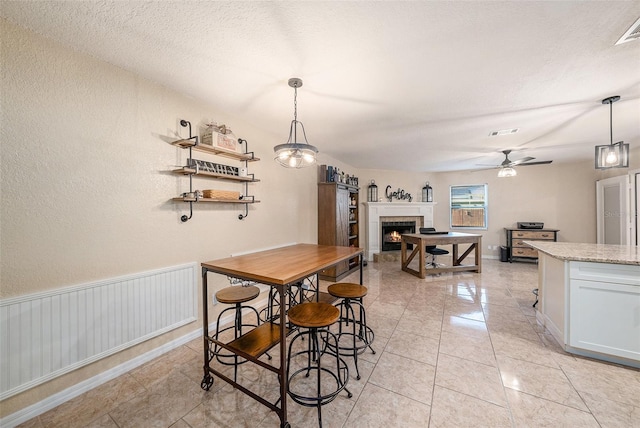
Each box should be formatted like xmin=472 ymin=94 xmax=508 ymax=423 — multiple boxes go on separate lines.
xmin=0 ymin=0 xmax=640 ymax=171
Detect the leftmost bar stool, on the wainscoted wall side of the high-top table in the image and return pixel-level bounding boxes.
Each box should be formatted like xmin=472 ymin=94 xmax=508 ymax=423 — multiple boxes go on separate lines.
xmin=212 ymin=285 xmax=262 ymax=381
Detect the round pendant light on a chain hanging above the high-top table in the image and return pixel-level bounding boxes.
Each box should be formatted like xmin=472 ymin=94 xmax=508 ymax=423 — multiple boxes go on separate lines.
xmin=273 ymin=77 xmax=318 ymax=168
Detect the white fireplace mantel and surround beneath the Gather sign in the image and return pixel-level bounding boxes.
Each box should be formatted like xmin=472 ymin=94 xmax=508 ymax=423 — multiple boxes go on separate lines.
xmin=364 ymin=202 xmax=436 ymax=260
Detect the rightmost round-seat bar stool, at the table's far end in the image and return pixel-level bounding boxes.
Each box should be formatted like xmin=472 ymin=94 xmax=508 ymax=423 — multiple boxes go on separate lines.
xmin=327 ymin=282 xmax=376 ymax=380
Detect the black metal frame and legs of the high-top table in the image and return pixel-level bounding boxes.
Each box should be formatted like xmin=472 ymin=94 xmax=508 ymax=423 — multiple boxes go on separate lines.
xmin=200 ymin=253 xmax=364 ymax=428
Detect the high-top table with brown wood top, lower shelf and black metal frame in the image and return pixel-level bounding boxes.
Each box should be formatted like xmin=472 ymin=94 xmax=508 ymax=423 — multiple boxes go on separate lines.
xmin=200 ymin=244 xmax=363 ymax=427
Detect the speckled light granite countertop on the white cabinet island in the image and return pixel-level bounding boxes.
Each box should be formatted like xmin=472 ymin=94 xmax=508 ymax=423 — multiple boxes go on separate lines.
xmin=524 ymin=241 xmax=640 ymax=265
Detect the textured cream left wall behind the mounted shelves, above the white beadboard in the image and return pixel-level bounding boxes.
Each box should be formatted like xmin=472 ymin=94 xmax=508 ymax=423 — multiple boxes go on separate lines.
xmin=0 ymin=20 xmax=324 ymax=417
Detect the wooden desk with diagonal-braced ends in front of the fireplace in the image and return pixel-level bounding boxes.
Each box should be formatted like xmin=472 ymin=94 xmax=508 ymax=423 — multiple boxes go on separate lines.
xmin=400 ymin=232 xmax=482 ymax=278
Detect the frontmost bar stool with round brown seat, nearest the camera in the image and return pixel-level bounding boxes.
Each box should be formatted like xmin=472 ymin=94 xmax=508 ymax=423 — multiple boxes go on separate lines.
xmin=287 ymin=302 xmax=353 ymax=427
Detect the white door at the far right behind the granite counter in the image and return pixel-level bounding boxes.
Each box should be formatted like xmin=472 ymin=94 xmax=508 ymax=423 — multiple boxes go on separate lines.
xmin=596 ymin=174 xmax=631 ymax=245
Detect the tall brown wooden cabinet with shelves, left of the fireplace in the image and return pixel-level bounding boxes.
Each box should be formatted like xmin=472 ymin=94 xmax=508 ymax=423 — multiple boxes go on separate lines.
xmin=318 ymin=183 xmax=360 ymax=281
